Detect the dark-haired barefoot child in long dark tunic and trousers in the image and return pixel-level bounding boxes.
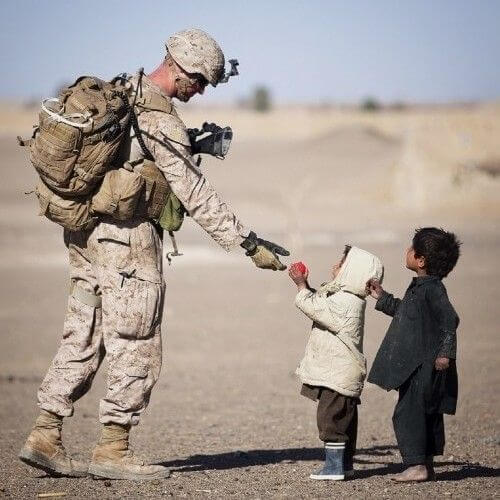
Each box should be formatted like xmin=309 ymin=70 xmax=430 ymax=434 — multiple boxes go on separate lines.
xmin=368 ymin=227 xmax=460 ymax=482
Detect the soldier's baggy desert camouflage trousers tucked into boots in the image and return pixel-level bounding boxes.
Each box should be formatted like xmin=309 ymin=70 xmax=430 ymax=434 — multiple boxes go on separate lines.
xmin=38 ymin=219 xmax=165 ymax=425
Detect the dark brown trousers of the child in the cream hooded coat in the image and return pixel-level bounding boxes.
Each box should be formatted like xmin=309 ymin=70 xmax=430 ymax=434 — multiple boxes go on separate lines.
xmin=302 ymin=386 xmax=359 ymax=470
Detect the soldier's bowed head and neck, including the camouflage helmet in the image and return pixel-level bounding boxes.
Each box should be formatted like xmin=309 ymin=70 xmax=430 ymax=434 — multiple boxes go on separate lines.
xmin=151 ymin=29 xmax=225 ymax=102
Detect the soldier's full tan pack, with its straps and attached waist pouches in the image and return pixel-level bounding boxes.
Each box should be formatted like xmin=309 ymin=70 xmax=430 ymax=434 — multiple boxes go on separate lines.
xmin=18 ymin=72 xmax=184 ymax=231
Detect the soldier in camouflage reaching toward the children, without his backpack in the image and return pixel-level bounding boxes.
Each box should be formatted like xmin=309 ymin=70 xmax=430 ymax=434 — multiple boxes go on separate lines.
xmin=20 ymin=29 xmax=289 ymax=480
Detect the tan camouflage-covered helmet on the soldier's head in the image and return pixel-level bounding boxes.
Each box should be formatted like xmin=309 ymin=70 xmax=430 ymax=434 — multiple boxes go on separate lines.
xmin=165 ymin=28 xmax=225 ymax=87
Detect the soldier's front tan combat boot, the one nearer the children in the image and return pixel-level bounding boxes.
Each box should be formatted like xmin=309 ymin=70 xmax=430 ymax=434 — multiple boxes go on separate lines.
xmin=89 ymin=424 xmax=170 ymax=481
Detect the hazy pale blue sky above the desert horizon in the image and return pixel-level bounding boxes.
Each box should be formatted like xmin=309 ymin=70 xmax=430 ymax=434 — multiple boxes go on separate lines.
xmin=0 ymin=0 xmax=500 ymax=102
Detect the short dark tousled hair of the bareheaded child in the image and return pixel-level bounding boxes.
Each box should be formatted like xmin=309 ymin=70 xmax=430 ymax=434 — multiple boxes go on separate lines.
xmin=413 ymin=227 xmax=462 ymax=278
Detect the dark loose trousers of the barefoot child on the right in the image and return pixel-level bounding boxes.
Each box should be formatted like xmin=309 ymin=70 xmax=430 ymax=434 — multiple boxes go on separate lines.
xmin=392 ymin=370 xmax=444 ymax=465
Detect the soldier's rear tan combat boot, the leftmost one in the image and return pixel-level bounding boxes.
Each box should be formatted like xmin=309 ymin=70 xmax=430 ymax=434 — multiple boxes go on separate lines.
xmin=19 ymin=410 xmax=87 ymax=477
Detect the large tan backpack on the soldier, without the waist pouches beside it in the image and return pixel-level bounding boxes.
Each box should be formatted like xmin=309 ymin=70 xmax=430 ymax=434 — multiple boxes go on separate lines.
xmin=18 ymin=76 xmax=131 ymax=231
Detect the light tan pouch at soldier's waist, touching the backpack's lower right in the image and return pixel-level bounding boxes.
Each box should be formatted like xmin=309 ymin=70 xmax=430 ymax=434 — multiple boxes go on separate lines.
xmin=91 ymin=168 xmax=144 ymax=220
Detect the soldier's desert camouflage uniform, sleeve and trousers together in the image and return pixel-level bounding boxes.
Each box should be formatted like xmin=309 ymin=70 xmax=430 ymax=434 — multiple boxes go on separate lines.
xmin=38 ymin=77 xmax=249 ymax=425
